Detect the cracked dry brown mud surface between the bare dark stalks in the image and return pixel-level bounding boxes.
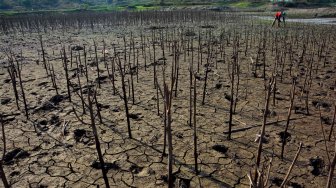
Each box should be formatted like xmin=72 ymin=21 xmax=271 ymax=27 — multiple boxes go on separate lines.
xmin=0 ymin=14 xmax=336 ymax=187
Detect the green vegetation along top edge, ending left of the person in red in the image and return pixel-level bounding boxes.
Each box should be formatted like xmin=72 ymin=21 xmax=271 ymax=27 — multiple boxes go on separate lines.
xmin=0 ymin=0 xmax=269 ymax=10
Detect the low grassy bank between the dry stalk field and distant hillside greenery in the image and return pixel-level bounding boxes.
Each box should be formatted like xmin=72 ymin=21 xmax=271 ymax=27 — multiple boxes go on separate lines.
xmin=0 ymin=0 xmax=336 ymax=18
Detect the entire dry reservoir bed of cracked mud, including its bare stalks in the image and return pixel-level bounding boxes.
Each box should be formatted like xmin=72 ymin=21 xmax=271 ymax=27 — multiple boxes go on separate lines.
xmin=0 ymin=11 xmax=336 ymax=187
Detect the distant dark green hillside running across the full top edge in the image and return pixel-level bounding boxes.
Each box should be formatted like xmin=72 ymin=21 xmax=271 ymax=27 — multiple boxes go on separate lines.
xmin=0 ymin=0 xmax=336 ymax=11
